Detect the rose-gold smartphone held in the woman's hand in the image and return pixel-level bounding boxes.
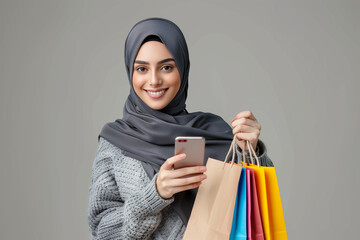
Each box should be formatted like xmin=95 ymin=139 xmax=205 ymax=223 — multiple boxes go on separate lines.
xmin=174 ymin=136 xmax=205 ymax=169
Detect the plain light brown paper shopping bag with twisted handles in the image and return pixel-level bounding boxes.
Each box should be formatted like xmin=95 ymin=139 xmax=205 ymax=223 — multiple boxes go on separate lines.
xmin=183 ymin=137 xmax=241 ymax=240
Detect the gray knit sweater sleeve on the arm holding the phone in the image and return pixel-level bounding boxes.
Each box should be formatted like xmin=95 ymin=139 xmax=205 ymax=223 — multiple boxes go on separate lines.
xmin=88 ymin=138 xmax=173 ymax=240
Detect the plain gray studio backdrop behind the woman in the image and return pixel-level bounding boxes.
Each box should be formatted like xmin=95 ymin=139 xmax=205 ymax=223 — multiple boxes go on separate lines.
xmin=0 ymin=0 xmax=360 ymax=239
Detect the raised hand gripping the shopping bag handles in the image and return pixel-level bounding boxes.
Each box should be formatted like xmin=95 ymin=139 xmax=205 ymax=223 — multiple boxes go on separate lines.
xmin=231 ymin=111 xmax=261 ymax=151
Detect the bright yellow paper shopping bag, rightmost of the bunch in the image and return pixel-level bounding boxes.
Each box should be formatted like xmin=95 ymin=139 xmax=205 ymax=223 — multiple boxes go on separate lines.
xmin=247 ymin=143 xmax=288 ymax=240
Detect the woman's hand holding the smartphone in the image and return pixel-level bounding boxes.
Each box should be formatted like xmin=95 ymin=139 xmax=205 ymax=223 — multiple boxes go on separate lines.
xmin=156 ymin=153 xmax=206 ymax=199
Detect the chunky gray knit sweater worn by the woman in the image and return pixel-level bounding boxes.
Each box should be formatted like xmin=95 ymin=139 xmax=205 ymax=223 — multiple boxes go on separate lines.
xmin=87 ymin=137 xmax=273 ymax=240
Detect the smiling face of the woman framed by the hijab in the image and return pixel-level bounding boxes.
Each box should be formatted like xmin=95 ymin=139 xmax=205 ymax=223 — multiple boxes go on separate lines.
xmin=132 ymin=41 xmax=181 ymax=110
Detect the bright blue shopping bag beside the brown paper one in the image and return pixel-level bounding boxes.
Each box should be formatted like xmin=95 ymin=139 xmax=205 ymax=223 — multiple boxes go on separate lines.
xmin=229 ymin=167 xmax=248 ymax=240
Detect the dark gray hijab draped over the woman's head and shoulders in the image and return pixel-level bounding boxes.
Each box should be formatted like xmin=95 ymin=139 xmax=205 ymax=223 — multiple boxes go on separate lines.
xmin=98 ymin=18 xmax=233 ymax=224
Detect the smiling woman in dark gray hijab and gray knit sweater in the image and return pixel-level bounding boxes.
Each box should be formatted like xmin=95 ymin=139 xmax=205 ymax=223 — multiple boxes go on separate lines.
xmin=88 ymin=18 xmax=272 ymax=239
